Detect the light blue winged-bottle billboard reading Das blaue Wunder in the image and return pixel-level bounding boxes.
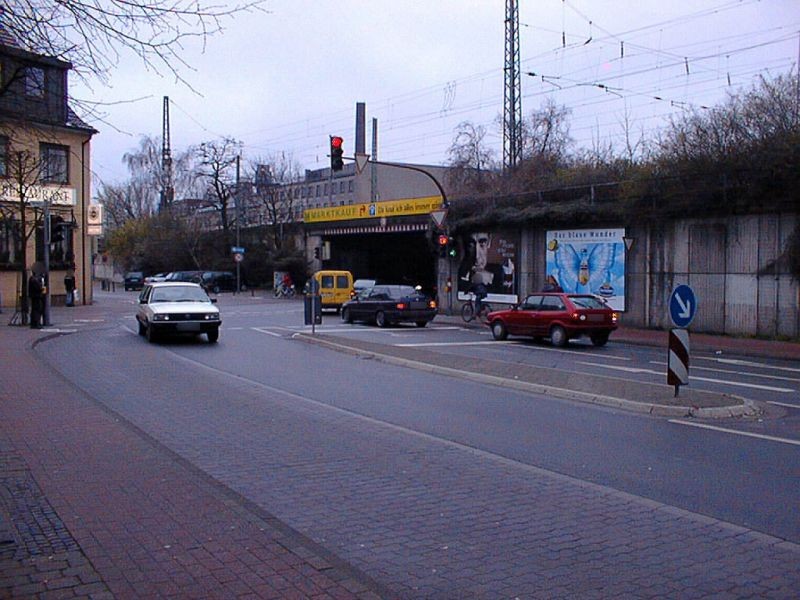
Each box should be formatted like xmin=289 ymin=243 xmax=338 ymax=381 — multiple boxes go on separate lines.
xmin=546 ymin=229 xmax=625 ymax=311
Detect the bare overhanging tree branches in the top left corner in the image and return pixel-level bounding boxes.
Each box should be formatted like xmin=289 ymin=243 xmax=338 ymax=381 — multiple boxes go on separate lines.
xmin=0 ymin=0 xmax=264 ymax=93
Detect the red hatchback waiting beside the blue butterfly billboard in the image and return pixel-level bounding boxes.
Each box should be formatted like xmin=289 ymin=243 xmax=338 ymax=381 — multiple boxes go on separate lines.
xmin=488 ymin=293 xmax=617 ymax=347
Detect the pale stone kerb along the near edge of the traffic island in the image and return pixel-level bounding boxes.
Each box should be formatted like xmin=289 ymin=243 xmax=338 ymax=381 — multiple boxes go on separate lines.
xmin=292 ymin=333 xmax=759 ymax=419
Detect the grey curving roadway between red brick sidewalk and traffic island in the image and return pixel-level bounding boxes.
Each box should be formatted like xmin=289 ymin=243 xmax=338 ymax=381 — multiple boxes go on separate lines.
xmin=29 ymin=295 xmax=800 ymax=597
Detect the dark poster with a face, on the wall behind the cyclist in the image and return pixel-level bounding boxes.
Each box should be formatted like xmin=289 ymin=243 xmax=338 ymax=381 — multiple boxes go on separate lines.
xmin=458 ymin=231 xmax=519 ymax=304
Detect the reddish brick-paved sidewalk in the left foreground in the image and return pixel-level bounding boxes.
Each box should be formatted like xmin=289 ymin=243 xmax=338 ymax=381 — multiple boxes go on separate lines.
xmin=0 ymin=307 xmax=385 ymax=599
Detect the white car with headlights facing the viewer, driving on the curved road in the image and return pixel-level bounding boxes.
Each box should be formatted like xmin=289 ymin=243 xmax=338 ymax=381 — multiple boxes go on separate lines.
xmin=136 ymin=281 xmax=222 ymax=343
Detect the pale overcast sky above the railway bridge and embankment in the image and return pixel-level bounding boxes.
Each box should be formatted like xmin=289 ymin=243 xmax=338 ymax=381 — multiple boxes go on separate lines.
xmin=71 ymin=0 xmax=800 ymax=188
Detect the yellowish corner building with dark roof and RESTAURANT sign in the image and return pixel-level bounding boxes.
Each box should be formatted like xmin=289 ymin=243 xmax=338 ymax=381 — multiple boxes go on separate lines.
xmin=0 ymin=37 xmax=97 ymax=310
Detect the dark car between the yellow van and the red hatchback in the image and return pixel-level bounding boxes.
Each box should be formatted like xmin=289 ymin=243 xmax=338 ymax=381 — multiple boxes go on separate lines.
xmin=342 ymin=285 xmax=436 ymax=327
